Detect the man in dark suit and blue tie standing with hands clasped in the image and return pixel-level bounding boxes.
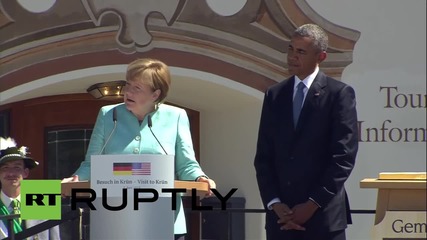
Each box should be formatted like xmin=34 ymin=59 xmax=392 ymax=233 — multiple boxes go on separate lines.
xmin=254 ymin=24 xmax=358 ymax=240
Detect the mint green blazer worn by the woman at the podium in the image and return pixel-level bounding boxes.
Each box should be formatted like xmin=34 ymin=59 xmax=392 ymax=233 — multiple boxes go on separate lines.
xmin=74 ymin=103 xmax=205 ymax=234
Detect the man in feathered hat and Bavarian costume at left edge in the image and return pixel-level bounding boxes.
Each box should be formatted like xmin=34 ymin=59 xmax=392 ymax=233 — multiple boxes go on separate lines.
xmin=0 ymin=137 xmax=60 ymax=240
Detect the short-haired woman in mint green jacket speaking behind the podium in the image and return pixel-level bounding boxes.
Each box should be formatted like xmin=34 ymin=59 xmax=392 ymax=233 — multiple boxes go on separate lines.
xmin=63 ymin=59 xmax=215 ymax=239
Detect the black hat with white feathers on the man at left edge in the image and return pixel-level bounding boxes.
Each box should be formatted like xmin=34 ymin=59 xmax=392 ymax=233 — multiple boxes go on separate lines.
xmin=0 ymin=137 xmax=39 ymax=169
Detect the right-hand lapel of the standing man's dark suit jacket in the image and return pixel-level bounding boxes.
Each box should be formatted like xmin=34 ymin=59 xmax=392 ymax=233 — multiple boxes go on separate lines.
xmin=296 ymin=72 xmax=327 ymax=133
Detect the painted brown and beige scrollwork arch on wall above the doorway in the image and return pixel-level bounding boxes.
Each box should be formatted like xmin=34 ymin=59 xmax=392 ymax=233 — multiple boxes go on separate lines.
xmin=0 ymin=0 xmax=360 ymax=97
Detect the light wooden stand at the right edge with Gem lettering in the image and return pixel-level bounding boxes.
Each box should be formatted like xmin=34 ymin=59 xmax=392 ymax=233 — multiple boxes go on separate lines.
xmin=360 ymin=172 xmax=427 ymax=239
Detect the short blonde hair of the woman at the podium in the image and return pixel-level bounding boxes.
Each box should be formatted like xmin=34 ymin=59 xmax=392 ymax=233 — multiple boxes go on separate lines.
xmin=126 ymin=58 xmax=171 ymax=103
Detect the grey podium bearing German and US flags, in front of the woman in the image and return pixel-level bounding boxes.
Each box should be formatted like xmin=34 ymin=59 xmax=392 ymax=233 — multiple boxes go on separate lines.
xmin=62 ymin=154 xmax=208 ymax=240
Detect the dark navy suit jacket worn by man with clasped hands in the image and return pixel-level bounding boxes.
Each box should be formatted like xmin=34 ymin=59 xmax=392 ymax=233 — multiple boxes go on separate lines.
xmin=254 ymin=72 xmax=358 ymax=234
